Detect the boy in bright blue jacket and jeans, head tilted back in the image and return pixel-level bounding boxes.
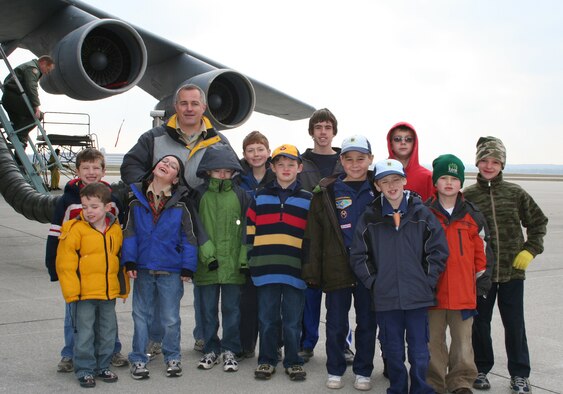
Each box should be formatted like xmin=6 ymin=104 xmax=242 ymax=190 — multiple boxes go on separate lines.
xmin=121 ymin=155 xmax=197 ymax=379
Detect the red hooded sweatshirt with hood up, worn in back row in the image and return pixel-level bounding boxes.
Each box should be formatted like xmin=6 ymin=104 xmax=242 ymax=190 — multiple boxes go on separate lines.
xmin=387 ymin=122 xmax=435 ymax=201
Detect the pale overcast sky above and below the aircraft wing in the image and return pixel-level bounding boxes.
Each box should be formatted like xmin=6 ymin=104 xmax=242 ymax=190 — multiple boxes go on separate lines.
xmin=4 ymin=0 xmax=563 ymax=164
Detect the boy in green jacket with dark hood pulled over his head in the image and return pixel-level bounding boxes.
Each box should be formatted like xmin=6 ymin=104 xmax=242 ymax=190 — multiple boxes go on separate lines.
xmin=194 ymin=145 xmax=250 ymax=372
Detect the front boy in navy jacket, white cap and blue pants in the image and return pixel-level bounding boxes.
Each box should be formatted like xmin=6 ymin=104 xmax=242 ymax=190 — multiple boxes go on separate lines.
xmin=350 ymin=159 xmax=449 ymax=394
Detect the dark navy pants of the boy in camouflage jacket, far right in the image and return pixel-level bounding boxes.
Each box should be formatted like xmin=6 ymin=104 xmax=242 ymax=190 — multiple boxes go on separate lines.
xmin=473 ymin=279 xmax=530 ymax=378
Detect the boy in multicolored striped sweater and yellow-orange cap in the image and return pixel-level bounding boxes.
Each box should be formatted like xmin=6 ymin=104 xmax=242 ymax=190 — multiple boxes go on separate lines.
xmin=247 ymin=144 xmax=312 ymax=380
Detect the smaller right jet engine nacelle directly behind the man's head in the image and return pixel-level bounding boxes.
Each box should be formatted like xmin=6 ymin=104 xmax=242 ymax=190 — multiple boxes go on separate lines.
xmin=156 ymin=69 xmax=256 ymax=130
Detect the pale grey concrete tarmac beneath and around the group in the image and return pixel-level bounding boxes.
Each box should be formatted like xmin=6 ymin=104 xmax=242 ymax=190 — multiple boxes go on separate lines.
xmin=0 ymin=180 xmax=563 ymax=394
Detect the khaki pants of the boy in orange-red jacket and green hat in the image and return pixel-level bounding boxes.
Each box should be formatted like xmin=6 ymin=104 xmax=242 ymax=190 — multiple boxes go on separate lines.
xmin=426 ymin=309 xmax=477 ymax=393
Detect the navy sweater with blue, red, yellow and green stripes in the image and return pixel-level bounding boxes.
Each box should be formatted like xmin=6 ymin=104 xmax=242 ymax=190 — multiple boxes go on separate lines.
xmin=246 ymin=181 xmax=312 ymax=289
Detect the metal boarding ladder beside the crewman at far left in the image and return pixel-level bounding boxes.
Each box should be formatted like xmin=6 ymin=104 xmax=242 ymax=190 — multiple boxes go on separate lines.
xmin=0 ymin=45 xmax=63 ymax=194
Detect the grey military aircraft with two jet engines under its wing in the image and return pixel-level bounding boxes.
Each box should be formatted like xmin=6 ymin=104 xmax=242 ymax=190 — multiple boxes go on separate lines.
xmin=0 ymin=0 xmax=314 ymax=222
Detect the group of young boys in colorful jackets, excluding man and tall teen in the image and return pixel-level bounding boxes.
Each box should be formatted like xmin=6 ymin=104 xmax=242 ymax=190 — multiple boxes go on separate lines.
xmin=47 ymin=119 xmax=547 ymax=394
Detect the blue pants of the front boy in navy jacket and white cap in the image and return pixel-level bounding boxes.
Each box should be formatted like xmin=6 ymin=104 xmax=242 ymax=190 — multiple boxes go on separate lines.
xmin=376 ymin=308 xmax=434 ymax=394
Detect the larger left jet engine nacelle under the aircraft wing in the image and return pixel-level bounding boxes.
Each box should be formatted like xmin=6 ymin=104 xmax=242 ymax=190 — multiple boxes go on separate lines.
xmin=41 ymin=19 xmax=147 ymax=100
